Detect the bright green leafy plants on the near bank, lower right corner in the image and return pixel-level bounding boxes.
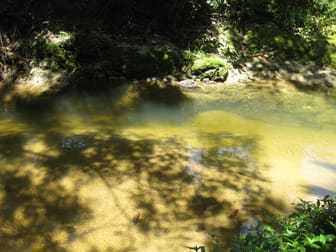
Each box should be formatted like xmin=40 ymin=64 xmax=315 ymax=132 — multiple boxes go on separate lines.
xmin=234 ymin=196 xmax=336 ymax=252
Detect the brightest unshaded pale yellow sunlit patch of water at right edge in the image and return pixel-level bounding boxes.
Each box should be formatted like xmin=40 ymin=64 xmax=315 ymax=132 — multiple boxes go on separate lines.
xmin=260 ymin=124 xmax=336 ymax=205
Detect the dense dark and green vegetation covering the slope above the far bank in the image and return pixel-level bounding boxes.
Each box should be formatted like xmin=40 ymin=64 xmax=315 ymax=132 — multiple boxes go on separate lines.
xmin=0 ymin=0 xmax=336 ymax=89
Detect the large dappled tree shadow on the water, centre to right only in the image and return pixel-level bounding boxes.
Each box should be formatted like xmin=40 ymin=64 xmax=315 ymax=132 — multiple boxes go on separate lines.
xmin=37 ymin=131 xmax=285 ymax=249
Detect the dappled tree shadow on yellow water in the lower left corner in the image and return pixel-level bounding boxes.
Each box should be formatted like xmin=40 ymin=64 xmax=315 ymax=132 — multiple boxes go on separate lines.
xmin=0 ymin=132 xmax=91 ymax=252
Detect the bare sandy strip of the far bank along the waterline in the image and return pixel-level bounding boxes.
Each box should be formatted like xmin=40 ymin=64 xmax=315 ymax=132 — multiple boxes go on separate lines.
xmin=0 ymin=50 xmax=336 ymax=101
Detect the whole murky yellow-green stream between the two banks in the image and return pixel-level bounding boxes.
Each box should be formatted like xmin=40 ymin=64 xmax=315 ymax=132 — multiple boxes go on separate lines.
xmin=0 ymin=82 xmax=336 ymax=251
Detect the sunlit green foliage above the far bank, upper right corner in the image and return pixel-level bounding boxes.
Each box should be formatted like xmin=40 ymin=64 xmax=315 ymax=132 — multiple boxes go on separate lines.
xmin=213 ymin=0 xmax=336 ymax=66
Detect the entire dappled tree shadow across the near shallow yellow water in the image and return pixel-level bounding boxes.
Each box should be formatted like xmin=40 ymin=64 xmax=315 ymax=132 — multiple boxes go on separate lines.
xmin=0 ymin=122 xmax=283 ymax=251
